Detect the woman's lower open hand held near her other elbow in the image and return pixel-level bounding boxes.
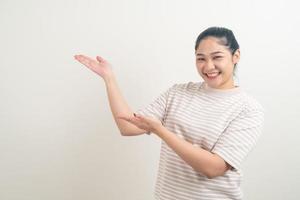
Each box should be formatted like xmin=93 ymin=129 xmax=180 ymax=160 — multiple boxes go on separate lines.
xmin=118 ymin=114 xmax=163 ymax=134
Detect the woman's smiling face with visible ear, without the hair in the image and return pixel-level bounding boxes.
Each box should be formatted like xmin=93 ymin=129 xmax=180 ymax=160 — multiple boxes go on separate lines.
xmin=196 ymin=37 xmax=240 ymax=89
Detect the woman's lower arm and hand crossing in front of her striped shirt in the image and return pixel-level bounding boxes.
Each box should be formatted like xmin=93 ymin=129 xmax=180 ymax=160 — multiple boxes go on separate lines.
xmin=120 ymin=115 xmax=231 ymax=178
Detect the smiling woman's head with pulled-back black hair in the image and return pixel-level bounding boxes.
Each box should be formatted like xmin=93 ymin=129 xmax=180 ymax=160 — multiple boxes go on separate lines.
xmin=195 ymin=27 xmax=240 ymax=89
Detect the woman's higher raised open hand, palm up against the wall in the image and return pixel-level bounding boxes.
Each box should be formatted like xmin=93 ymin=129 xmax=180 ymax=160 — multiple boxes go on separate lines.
xmin=74 ymin=55 xmax=112 ymax=80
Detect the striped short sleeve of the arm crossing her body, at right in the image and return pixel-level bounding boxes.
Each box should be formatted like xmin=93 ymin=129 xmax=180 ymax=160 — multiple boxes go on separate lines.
xmin=212 ymin=108 xmax=264 ymax=169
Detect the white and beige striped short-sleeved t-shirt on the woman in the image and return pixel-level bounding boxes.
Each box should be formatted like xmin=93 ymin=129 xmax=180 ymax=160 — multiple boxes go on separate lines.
xmin=137 ymin=82 xmax=264 ymax=200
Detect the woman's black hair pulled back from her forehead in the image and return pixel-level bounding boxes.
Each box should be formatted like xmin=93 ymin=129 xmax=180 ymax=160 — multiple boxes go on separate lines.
xmin=195 ymin=27 xmax=240 ymax=70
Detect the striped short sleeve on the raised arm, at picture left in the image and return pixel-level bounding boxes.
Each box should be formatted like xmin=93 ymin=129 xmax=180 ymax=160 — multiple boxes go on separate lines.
xmin=136 ymin=85 xmax=175 ymax=123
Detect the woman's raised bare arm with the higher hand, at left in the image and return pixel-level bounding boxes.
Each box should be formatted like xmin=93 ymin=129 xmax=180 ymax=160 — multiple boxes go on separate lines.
xmin=74 ymin=55 xmax=147 ymax=136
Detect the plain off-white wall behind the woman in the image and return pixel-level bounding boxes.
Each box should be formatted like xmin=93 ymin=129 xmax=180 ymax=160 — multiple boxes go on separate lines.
xmin=0 ymin=0 xmax=300 ymax=200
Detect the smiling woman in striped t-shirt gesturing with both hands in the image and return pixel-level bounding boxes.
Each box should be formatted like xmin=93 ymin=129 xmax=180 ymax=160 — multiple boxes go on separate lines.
xmin=75 ymin=27 xmax=264 ymax=200
